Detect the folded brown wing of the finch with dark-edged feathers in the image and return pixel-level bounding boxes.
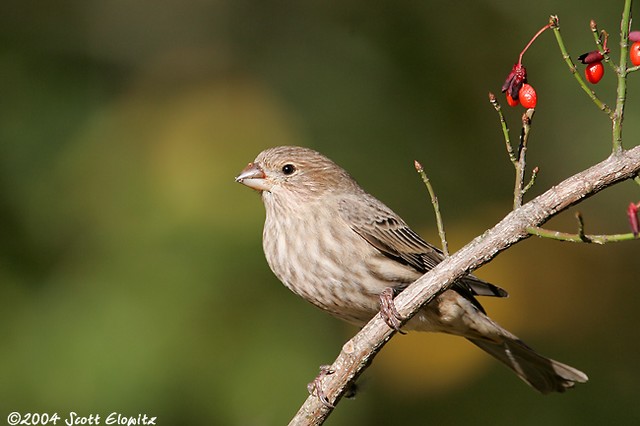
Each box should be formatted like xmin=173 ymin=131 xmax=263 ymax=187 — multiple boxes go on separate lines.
xmin=339 ymin=194 xmax=507 ymax=297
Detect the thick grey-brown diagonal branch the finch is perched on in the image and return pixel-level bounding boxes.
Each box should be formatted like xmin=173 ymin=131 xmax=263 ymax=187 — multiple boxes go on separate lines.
xmin=289 ymin=146 xmax=640 ymax=425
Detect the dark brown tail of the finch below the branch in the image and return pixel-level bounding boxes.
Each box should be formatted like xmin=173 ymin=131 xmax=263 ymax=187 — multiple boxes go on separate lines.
xmin=468 ymin=336 xmax=589 ymax=394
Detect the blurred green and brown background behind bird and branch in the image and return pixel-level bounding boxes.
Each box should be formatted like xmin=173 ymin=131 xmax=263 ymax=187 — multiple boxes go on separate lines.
xmin=0 ymin=0 xmax=640 ymax=425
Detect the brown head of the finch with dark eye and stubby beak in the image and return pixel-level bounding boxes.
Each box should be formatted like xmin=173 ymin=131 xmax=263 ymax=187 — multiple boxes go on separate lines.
xmin=236 ymin=146 xmax=357 ymax=197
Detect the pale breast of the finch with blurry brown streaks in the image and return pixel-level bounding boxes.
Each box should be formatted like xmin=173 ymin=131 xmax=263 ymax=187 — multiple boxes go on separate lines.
xmin=263 ymin=201 xmax=419 ymax=325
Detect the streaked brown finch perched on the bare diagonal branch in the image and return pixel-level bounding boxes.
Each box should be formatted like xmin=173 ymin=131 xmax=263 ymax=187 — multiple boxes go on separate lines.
xmin=236 ymin=146 xmax=587 ymax=393
